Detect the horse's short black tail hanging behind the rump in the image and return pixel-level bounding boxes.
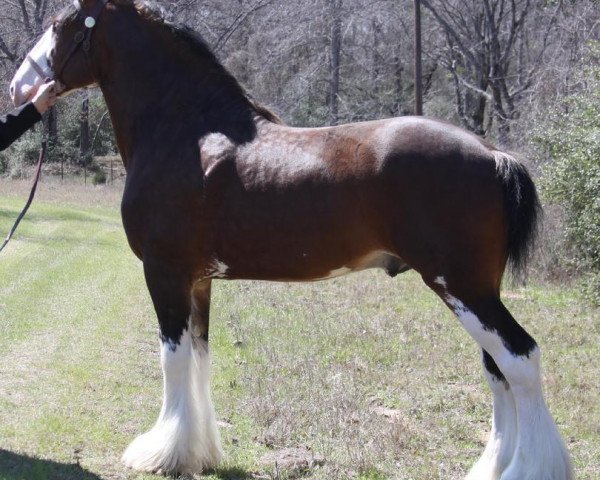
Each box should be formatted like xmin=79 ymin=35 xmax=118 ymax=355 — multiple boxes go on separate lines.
xmin=493 ymin=150 xmax=542 ymax=278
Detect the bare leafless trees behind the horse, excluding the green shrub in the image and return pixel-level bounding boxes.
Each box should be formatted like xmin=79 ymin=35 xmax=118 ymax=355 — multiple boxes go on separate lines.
xmin=0 ymin=0 xmax=600 ymax=149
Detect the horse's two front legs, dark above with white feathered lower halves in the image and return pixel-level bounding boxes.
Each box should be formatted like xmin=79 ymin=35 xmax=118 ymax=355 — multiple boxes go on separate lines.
xmin=123 ymin=259 xmax=222 ymax=474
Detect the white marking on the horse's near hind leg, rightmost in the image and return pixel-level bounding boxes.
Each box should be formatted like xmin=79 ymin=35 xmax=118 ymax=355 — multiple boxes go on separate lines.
xmin=436 ymin=284 xmax=573 ymax=480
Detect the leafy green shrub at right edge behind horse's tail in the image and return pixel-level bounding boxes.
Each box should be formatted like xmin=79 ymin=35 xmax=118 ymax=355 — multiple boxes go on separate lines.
xmin=540 ymin=44 xmax=600 ymax=303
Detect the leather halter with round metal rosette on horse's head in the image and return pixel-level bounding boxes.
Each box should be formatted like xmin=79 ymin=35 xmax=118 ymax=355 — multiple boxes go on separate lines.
xmin=27 ymin=0 xmax=109 ymax=86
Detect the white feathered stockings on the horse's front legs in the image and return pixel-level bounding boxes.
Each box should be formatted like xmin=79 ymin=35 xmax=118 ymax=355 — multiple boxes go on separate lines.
xmin=122 ymin=320 xmax=223 ymax=473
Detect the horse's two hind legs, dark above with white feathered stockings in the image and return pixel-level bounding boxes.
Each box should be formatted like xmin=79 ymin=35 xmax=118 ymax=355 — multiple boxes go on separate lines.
xmin=427 ymin=277 xmax=573 ymax=480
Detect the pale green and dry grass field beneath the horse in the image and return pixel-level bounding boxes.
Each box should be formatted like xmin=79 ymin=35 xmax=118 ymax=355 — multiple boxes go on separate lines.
xmin=0 ymin=180 xmax=600 ymax=480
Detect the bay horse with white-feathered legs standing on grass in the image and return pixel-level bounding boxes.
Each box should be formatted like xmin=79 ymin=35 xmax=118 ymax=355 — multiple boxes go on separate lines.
xmin=10 ymin=0 xmax=573 ymax=480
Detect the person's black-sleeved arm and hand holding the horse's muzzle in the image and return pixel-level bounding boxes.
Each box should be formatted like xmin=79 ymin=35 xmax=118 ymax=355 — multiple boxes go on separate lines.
xmin=0 ymin=82 xmax=56 ymax=151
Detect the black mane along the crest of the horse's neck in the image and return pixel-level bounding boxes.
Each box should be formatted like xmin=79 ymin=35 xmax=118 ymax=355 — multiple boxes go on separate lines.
xmin=113 ymin=0 xmax=283 ymax=124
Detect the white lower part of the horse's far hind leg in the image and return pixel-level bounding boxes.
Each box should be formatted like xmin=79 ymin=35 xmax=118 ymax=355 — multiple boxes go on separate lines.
xmin=466 ymin=367 xmax=517 ymax=480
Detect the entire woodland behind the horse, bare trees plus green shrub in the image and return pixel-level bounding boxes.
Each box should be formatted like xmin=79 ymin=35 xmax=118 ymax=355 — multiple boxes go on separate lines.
xmin=0 ymin=0 xmax=600 ymax=298
